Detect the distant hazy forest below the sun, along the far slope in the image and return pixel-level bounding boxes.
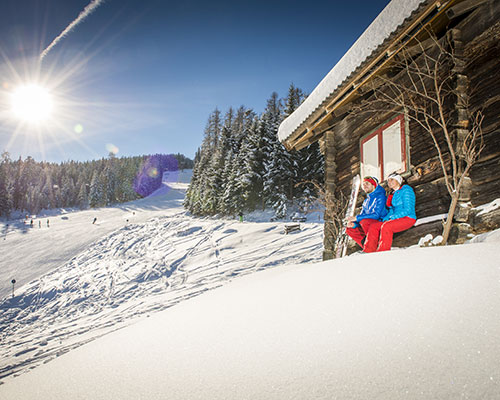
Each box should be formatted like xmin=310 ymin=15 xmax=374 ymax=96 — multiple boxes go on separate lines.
xmin=0 ymin=152 xmax=193 ymax=217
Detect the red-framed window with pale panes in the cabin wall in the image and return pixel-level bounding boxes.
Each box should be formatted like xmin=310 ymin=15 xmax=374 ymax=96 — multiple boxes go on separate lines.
xmin=361 ymin=114 xmax=408 ymax=181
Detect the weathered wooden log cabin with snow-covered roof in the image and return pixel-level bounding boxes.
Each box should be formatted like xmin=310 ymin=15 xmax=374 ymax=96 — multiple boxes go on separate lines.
xmin=278 ymin=0 xmax=500 ymax=259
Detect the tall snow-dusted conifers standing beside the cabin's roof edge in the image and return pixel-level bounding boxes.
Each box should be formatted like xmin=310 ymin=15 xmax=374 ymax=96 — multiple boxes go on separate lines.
xmin=184 ymin=84 xmax=324 ymax=218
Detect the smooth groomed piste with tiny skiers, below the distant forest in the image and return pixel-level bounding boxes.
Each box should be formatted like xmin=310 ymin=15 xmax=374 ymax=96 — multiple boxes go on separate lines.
xmin=0 ymin=171 xmax=192 ymax=299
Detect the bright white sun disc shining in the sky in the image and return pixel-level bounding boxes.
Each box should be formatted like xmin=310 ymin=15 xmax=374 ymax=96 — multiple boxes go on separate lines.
xmin=12 ymin=84 xmax=53 ymax=124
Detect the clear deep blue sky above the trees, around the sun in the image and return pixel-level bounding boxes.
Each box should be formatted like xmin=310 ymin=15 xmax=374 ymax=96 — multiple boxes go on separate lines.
xmin=0 ymin=0 xmax=388 ymax=162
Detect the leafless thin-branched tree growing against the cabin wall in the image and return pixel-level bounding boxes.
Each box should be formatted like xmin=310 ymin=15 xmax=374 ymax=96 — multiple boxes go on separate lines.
xmin=360 ymin=31 xmax=484 ymax=244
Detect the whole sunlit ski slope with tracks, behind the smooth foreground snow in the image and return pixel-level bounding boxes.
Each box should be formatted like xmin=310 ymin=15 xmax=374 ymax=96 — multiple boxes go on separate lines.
xmin=0 ymin=169 xmax=323 ymax=380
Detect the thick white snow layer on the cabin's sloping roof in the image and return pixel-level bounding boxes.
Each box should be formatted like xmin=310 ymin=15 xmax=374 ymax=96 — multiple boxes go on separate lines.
xmin=278 ymin=0 xmax=426 ymax=142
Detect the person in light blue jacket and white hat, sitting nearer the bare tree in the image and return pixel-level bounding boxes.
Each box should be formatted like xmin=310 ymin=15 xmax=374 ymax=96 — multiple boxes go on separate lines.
xmin=365 ymin=174 xmax=417 ymax=252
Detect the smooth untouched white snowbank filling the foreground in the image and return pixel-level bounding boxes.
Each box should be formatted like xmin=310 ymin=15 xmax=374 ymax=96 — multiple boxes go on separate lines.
xmin=0 ymin=236 xmax=500 ymax=400
